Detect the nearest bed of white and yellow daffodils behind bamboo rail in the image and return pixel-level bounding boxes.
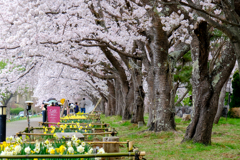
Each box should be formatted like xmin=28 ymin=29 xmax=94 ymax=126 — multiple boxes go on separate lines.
xmin=0 ymin=136 xmax=105 ymax=155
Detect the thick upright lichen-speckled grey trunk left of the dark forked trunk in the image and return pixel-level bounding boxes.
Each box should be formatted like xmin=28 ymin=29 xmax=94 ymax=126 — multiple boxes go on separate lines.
xmin=147 ymin=13 xmax=175 ymax=132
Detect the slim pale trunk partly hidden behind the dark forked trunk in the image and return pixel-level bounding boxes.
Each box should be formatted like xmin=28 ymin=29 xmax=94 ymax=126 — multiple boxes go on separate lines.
xmin=214 ymin=81 xmax=228 ymax=124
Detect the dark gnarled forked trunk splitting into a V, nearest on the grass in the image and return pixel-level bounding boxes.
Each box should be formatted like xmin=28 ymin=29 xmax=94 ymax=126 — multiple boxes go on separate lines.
xmin=183 ymin=22 xmax=236 ymax=145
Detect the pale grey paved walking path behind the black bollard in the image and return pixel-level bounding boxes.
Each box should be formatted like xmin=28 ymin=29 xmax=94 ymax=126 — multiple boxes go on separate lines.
xmin=6 ymin=117 xmax=42 ymax=137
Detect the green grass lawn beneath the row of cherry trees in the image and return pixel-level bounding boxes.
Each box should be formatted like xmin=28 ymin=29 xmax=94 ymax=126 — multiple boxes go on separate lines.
xmin=101 ymin=115 xmax=240 ymax=160
